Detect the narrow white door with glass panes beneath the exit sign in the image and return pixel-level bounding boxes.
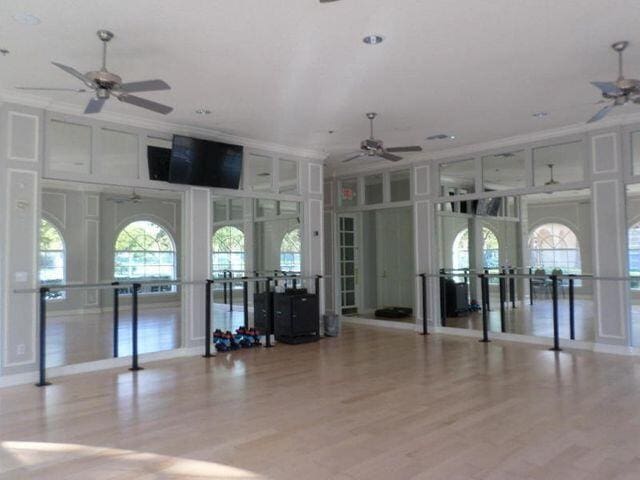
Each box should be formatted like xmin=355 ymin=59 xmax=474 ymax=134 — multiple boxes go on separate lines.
xmin=338 ymin=215 xmax=358 ymax=314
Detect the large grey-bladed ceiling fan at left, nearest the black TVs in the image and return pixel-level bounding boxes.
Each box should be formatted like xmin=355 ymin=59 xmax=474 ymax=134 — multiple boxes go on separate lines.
xmin=16 ymin=30 xmax=173 ymax=115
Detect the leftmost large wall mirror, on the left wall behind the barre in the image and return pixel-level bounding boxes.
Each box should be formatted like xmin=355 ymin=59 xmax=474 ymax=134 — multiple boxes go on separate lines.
xmin=39 ymin=180 xmax=182 ymax=366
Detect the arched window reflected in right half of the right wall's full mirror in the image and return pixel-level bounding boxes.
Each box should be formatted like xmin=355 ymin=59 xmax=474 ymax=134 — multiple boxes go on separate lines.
xmin=529 ymin=223 xmax=582 ymax=274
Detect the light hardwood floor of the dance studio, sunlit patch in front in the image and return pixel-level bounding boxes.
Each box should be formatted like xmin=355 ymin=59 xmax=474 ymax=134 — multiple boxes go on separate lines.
xmin=0 ymin=326 xmax=640 ymax=480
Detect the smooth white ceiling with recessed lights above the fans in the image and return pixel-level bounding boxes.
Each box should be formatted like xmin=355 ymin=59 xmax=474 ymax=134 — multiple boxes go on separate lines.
xmin=0 ymin=0 xmax=640 ymax=161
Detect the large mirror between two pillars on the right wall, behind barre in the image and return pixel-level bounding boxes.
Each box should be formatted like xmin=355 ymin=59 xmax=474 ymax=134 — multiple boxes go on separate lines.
xmin=436 ymin=190 xmax=595 ymax=341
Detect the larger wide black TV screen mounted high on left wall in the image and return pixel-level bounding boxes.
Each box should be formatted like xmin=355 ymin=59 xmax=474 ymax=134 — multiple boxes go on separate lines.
xmin=169 ymin=135 xmax=243 ymax=190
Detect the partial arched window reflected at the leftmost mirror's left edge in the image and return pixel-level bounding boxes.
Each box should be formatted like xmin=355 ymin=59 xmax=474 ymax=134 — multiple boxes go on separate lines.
xmin=39 ymin=219 xmax=66 ymax=300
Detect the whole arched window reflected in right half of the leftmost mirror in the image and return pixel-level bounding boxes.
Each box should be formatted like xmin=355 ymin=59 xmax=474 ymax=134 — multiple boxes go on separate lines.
xmin=114 ymin=220 xmax=176 ymax=292
